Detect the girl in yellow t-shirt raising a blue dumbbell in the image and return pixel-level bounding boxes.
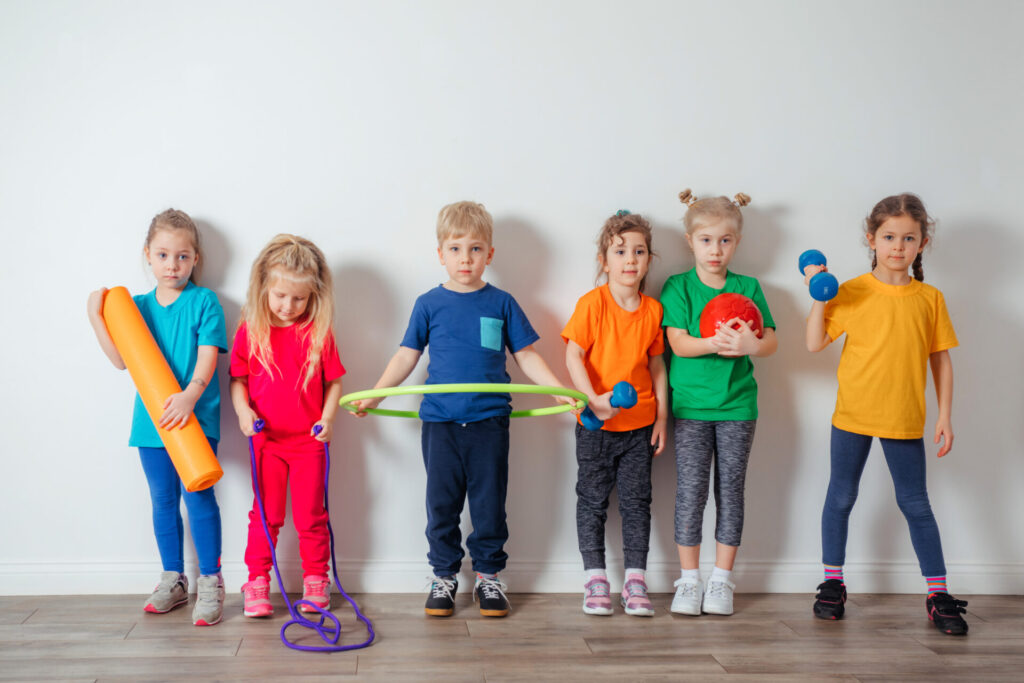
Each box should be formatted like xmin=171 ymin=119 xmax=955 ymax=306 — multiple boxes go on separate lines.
xmin=804 ymin=195 xmax=968 ymax=635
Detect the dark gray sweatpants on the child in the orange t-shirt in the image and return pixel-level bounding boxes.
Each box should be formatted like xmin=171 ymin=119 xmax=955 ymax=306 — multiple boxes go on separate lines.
xmin=575 ymin=425 xmax=654 ymax=569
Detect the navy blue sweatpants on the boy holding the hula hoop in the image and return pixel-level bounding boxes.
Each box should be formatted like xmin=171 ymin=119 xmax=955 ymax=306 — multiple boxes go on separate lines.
xmin=422 ymin=416 xmax=509 ymax=577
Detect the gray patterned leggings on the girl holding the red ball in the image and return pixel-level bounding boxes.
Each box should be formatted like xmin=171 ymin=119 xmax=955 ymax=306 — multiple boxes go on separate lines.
xmin=675 ymin=420 xmax=757 ymax=546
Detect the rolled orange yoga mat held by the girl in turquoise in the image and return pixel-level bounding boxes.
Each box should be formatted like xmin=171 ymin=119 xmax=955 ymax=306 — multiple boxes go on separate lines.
xmin=103 ymin=287 xmax=224 ymax=492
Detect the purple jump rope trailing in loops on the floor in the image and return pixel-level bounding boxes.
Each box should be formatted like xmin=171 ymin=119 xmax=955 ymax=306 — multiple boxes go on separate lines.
xmin=249 ymin=420 xmax=375 ymax=652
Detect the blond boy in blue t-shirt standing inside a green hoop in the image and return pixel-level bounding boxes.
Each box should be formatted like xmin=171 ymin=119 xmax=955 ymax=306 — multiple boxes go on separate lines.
xmin=354 ymin=202 xmax=574 ymax=616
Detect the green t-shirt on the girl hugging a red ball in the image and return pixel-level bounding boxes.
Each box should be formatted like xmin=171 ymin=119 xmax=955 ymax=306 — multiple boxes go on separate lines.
xmin=662 ymin=268 xmax=775 ymax=421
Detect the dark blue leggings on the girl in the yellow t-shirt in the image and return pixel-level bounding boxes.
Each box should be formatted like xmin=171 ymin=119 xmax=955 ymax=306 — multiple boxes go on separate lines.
xmin=821 ymin=427 xmax=946 ymax=577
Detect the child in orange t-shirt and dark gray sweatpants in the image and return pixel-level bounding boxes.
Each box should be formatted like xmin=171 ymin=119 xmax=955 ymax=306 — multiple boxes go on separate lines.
xmin=562 ymin=211 xmax=668 ymax=616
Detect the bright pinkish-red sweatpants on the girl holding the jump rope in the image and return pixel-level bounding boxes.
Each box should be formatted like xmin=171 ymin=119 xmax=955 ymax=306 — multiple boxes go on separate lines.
xmin=246 ymin=437 xmax=331 ymax=581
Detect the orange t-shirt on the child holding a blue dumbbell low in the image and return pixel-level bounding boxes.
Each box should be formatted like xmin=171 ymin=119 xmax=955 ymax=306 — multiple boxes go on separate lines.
xmin=562 ymin=285 xmax=665 ymax=432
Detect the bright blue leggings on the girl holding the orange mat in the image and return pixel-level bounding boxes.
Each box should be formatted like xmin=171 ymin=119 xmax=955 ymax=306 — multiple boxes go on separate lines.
xmin=138 ymin=438 xmax=220 ymax=574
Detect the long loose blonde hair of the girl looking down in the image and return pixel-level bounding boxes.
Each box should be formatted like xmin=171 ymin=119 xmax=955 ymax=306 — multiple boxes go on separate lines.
xmin=239 ymin=233 xmax=334 ymax=391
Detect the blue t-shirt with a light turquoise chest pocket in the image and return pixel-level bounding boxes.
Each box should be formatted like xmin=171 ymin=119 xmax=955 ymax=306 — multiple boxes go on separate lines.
xmin=401 ymin=285 xmax=540 ymax=423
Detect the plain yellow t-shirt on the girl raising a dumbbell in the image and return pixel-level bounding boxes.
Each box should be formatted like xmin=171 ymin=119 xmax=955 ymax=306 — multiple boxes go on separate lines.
xmin=825 ymin=272 xmax=958 ymax=438
